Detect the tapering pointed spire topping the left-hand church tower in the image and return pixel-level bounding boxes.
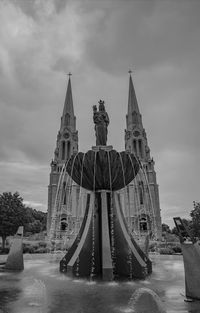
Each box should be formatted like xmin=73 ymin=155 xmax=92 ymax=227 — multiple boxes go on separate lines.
xmin=61 ymin=73 xmax=76 ymax=131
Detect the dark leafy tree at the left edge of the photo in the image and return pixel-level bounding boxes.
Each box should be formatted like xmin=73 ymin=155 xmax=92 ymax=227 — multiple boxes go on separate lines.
xmin=0 ymin=192 xmax=29 ymax=249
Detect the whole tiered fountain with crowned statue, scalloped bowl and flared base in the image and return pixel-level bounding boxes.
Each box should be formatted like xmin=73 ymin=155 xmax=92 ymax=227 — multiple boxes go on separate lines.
xmin=60 ymin=100 xmax=152 ymax=281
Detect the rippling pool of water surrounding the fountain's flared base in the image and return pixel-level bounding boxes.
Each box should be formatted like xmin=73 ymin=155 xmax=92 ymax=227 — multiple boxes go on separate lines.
xmin=0 ymin=254 xmax=200 ymax=313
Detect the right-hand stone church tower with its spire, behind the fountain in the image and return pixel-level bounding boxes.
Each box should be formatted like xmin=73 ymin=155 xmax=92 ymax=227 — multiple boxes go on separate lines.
xmin=125 ymin=71 xmax=161 ymax=238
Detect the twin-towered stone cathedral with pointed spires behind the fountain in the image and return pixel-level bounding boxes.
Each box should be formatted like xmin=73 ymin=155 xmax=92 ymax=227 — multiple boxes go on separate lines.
xmin=47 ymin=72 xmax=161 ymax=239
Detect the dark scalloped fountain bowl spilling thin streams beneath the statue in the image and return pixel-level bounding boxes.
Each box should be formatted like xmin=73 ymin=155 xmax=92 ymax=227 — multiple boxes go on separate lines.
xmin=66 ymin=150 xmax=140 ymax=191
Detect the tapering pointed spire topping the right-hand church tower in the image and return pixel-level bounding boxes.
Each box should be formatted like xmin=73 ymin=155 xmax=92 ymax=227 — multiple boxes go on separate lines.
xmin=126 ymin=71 xmax=143 ymax=129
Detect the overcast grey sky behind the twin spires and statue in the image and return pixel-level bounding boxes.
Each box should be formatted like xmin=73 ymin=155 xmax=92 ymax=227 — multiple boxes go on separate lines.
xmin=0 ymin=0 xmax=200 ymax=226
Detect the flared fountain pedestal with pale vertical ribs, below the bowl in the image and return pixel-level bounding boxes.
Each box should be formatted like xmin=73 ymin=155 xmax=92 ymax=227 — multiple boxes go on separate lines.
xmin=60 ymin=190 xmax=152 ymax=281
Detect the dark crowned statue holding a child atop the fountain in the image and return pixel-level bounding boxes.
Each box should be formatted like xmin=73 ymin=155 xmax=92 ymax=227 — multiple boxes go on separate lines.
xmin=93 ymin=100 xmax=109 ymax=146
